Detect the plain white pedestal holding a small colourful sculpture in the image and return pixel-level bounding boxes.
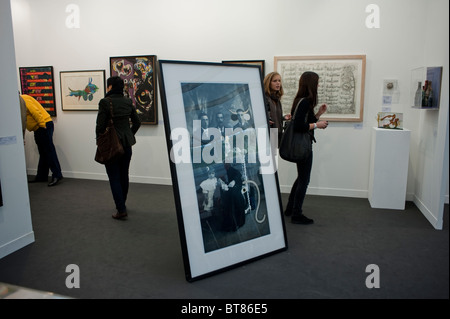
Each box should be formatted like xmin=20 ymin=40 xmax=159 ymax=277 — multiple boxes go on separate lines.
xmin=369 ymin=127 xmax=411 ymax=209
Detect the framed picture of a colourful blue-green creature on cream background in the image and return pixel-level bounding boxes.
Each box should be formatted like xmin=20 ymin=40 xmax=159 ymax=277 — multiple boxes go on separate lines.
xmin=59 ymin=70 xmax=106 ymax=111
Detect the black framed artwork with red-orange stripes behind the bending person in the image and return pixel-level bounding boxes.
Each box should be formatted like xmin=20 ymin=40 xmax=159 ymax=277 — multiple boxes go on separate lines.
xmin=19 ymin=66 xmax=56 ymax=117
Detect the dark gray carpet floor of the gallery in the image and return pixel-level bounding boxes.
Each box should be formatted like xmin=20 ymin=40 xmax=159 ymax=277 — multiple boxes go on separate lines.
xmin=0 ymin=178 xmax=449 ymax=299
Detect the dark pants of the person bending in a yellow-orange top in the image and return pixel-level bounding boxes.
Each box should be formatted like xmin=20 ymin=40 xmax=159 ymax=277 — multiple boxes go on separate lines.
xmin=34 ymin=121 xmax=62 ymax=180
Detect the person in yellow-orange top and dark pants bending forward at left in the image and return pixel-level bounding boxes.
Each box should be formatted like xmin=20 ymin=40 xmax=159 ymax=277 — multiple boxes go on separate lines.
xmin=20 ymin=94 xmax=63 ymax=186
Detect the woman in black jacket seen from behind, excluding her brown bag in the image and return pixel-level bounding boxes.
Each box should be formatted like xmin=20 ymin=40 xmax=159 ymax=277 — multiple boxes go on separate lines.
xmin=95 ymin=76 xmax=141 ymax=219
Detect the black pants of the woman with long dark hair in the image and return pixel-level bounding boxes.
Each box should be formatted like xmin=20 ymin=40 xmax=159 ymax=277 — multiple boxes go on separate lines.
xmin=287 ymin=152 xmax=313 ymax=216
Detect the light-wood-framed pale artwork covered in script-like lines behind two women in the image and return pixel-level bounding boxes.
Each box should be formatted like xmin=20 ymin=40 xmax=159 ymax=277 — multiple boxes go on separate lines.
xmin=274 ymin=55 xmax=366 ymax=122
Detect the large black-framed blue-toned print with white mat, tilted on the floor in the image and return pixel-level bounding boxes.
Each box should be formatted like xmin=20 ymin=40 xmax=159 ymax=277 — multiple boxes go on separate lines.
xmin=158 ymin=60 xmax=287 ymax=281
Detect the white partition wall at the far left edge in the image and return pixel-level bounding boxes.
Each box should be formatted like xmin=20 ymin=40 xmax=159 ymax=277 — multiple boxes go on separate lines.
xmin=0 ymin=0 xmax=34 ymax=258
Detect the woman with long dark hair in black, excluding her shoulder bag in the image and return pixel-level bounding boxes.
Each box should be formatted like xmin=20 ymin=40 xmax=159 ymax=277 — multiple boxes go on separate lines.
xmin=285 ymin=72 xmax=328 ymax=224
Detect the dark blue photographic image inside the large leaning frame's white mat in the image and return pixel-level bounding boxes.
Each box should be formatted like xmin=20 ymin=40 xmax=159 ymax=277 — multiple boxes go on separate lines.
xmin=181 ymin=83 xmax=270 ymax=252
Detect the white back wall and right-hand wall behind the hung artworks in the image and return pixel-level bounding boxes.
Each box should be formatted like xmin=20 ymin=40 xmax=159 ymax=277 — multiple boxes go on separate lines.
xmin=7 ymin=0 xmax=449 ymax=228
